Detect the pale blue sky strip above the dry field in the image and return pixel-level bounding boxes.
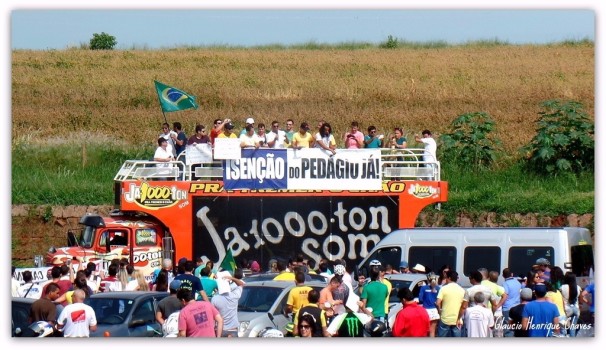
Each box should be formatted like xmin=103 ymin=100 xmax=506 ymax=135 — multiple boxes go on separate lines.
xmin=10 ymin=8 xmax=595 ymax=50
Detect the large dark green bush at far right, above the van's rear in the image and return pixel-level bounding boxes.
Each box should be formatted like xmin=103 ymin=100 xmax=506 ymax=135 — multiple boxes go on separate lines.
xmin=521 ymin=100 xmax=595 ymax=174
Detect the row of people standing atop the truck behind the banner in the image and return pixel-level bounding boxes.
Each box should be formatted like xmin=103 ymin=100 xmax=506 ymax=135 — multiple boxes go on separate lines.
xmin=154 ymin=117 xmax=437 ymax=162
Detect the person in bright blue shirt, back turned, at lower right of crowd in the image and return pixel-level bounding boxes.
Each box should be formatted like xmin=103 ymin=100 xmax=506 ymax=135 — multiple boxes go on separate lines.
xmin=522 ymin=283 xmax=560 ymax=338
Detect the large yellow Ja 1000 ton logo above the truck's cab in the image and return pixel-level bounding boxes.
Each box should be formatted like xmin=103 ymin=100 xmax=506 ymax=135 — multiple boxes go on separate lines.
xmin=124 ymin=182 xmax=187 ymax=209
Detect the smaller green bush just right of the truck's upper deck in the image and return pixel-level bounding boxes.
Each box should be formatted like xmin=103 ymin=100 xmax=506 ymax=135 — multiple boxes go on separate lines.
xmin=440 ymin=112 xmax=501 ymax=168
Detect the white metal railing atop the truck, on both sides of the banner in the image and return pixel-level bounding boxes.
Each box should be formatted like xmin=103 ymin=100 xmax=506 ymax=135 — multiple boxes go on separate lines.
xmin=114 ymin=148 xmax=441 ymax=181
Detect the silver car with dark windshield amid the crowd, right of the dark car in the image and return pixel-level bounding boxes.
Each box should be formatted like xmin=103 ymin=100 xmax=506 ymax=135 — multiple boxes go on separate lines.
xmin=238 ymin=281 xmax=326 ymax=337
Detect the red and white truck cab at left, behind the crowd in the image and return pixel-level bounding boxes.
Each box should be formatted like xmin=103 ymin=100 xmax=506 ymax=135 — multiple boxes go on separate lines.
xmin=46 ymin=211 xmax=167 ymax=275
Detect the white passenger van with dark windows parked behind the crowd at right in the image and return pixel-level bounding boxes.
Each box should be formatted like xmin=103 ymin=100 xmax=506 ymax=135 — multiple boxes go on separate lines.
xmin=358 ymin=227 xmax=594 ymax=287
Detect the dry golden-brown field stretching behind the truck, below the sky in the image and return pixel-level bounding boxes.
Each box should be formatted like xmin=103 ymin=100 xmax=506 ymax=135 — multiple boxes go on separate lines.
xmin=11 ymin=45 xmax=595 ymax=154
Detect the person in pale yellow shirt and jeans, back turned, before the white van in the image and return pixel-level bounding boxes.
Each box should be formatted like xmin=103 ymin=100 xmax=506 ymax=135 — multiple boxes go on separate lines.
xmin=436 ymin=270 xmax=467 ymax=337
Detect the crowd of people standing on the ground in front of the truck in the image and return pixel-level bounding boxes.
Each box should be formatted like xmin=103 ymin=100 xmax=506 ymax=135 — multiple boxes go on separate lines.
xmin=12 ymin=254 xmax=595 ymax=337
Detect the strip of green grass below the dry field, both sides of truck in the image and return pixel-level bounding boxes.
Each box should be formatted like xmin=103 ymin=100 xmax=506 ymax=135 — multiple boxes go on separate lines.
xmin=12 ymin=145 xmax=594 ymax=214
